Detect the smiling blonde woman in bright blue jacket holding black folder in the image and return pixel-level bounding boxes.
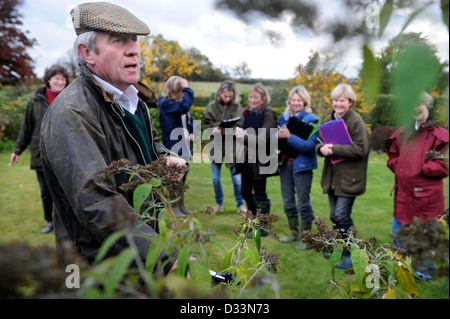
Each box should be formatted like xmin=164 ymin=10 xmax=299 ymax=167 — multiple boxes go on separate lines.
xmin=277 ymin=85 xmax=319 ymax=250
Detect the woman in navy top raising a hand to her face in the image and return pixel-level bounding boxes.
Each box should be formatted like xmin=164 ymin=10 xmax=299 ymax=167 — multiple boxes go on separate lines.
xmin=159 ymin=75 xmax=194 ymax=217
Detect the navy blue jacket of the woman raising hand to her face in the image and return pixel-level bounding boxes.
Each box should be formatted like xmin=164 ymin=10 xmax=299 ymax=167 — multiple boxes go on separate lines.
xmin=159 ymin=88 xmax=194 ymax=155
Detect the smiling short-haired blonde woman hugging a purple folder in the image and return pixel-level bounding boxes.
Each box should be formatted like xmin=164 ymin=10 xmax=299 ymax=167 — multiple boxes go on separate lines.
xmin=316 ymin=83 xmax=371 ymax=268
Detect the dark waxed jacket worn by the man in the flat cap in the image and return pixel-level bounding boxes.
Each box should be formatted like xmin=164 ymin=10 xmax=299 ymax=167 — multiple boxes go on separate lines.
xmin=40 ymin=70 xmax=173 ymax=267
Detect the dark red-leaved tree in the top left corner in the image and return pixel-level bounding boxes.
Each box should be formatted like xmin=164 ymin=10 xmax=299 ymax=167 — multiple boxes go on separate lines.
xmin=0 ymin=0 xmax=36 ymax=84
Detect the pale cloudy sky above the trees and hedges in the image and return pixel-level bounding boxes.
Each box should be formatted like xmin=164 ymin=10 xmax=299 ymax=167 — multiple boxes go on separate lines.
xmin=19 ymin=0 xmax=449 ymax=79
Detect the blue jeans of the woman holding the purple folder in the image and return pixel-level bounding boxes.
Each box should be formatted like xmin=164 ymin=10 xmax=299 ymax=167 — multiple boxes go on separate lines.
xmin=328 ymin=192 xmax=356 ymax=233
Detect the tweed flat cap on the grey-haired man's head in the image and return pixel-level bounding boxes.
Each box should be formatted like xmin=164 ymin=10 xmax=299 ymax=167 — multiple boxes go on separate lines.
xmin=70 ymin=2 xmax=150 ymax=35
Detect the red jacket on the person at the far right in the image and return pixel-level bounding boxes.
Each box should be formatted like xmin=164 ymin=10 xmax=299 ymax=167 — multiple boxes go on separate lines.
xmin=387 ymin=122 xmax=449 ymax=225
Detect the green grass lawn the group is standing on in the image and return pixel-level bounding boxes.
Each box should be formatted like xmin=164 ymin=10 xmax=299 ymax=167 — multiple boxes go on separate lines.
xmin=0 ymin=151 xmax=449 ymax=299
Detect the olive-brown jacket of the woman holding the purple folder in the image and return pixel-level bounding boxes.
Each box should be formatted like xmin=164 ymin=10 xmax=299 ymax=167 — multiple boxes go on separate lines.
xmin=316 ymin=109 xmax=371 ymax=197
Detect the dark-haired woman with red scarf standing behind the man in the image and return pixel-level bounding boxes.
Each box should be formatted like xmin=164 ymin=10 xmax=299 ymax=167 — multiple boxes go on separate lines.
xmin=10 ymin=65 xmax=69 ymax=234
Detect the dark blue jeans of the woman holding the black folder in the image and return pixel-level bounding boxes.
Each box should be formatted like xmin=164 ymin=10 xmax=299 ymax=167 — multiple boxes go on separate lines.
xmin=280 ymin=162 xmax=314 ymax=223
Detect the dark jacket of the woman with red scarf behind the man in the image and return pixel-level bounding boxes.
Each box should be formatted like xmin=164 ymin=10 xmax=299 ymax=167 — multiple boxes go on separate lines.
xmin=14 ymin=87 xmax=49 ymax=171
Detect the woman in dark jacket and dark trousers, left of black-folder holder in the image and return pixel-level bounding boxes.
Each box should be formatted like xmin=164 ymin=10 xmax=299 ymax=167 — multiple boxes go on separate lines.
xmin=236 ymin=83 xmax=278 ymax=236
